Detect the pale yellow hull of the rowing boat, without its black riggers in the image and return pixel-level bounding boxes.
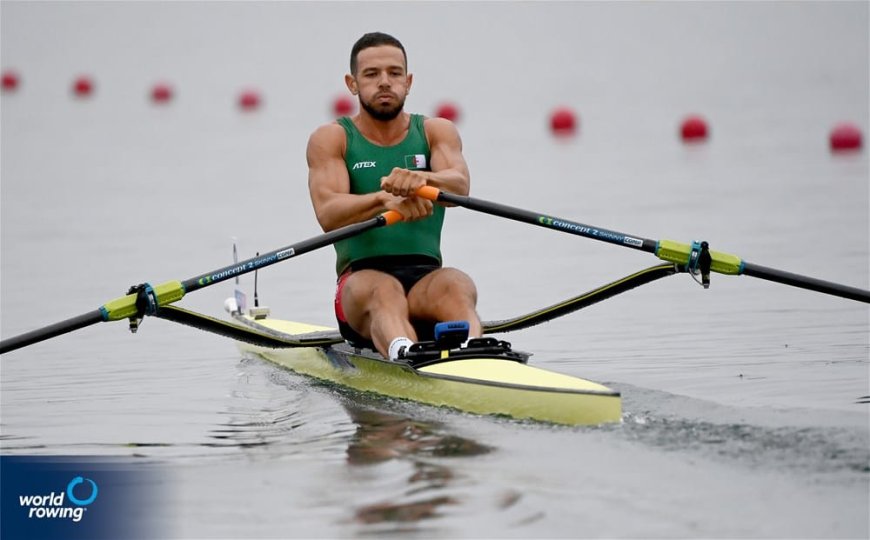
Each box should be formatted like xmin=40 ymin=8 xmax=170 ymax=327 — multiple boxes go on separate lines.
xmin=228 ymin=316 xmax=622 ymax=425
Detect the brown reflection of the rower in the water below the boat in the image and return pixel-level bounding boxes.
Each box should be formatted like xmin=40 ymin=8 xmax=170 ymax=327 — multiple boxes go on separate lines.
xmin=344 ymin=400 xmax=492 ymax=524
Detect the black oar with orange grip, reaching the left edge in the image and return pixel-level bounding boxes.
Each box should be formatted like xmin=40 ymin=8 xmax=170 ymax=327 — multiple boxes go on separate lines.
xmin=0 ymin=211 xmax=402 ymax=354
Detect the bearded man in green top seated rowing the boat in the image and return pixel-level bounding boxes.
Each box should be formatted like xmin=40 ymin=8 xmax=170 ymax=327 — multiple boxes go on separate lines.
xmin=307 ymin=32 xmax=481 ymax=360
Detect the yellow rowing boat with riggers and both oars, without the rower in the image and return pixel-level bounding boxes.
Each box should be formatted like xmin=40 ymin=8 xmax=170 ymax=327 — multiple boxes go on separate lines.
xmin=0 ymin=192 xmax=870 ymax=424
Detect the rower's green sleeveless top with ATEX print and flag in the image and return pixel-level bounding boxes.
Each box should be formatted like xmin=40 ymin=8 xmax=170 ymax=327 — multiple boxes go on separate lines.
xmin=335 ymin=114 xmax=444 ymax=274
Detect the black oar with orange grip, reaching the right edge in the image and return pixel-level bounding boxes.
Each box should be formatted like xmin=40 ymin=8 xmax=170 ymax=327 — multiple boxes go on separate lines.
xmin=417 ymin=186 xmax=870 ymax=303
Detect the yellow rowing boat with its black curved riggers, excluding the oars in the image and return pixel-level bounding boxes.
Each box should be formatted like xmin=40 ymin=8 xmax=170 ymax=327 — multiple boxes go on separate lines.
xmin=154 ymin=264 xmax=679 ymax=425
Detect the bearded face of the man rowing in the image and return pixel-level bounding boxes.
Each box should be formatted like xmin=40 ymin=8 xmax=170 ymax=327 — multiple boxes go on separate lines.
xmin=345 ymin=45 xmax=413 ymax=121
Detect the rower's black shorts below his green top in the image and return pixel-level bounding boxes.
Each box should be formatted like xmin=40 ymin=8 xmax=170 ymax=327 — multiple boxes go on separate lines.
xmin=335 ymin=255 xmax=441 ymax=349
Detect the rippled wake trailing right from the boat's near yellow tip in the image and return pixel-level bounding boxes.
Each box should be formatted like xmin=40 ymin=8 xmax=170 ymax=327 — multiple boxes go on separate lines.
xmin=612 ymin=387 xmax=870 ymax=482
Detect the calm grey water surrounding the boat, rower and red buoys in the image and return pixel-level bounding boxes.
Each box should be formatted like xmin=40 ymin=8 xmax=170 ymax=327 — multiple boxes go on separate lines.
xmin=0 ymin=2 xmax=870 ymax=538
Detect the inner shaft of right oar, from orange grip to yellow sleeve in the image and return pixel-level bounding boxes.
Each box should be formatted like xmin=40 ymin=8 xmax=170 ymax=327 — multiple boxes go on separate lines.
xmin=417 ymin=186 xmax=656 ymax=253
